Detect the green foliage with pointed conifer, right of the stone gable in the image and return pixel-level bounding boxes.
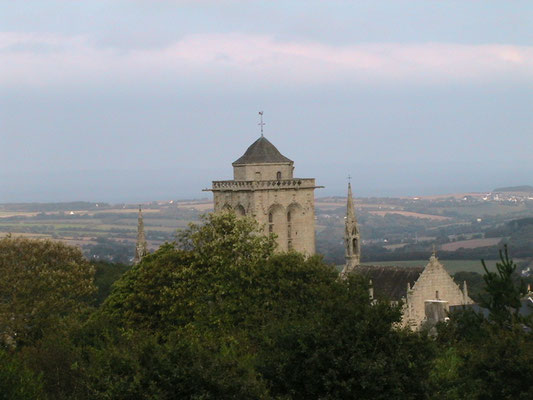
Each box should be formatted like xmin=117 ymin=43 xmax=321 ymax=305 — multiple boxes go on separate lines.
xmin=432 ymin=248 xmax=533 ymax=400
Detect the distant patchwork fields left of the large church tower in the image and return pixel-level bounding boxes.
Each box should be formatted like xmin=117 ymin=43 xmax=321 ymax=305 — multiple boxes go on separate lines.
xmin=0 ymin=201 xmax=212 ymax=253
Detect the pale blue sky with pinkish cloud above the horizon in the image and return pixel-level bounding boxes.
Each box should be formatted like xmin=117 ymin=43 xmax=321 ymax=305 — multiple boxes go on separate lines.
xmin=0 ymin=0 xmax=533 ymax=203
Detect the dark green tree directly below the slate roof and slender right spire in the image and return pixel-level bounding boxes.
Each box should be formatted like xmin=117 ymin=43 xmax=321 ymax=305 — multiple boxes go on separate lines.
xmin=257 ymin=274 xmax=433 ymax=399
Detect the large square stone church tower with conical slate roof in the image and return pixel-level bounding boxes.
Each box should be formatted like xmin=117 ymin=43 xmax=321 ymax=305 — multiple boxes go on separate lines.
xmin=208 ymin=135 xmax=322 ymax=255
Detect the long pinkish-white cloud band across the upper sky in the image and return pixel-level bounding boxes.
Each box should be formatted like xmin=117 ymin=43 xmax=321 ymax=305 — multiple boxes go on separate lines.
xmin=0 ymin=32 xmax=533 ymax=87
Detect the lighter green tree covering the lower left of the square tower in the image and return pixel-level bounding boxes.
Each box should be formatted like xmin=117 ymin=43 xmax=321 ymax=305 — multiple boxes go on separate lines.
xmin=102 ymin=213 xmax=275 ymax=334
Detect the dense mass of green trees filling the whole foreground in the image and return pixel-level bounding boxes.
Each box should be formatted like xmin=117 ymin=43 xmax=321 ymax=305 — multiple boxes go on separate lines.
xmin=0 ymin=217 xmax=533 ymax=400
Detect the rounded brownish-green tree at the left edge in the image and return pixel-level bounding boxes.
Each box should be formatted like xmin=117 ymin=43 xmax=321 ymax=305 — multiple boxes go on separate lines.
xmin=0 ymin=236 xmax=96 ymax=347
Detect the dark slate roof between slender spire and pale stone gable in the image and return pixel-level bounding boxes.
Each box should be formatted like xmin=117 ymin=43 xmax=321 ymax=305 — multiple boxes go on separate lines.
xmin=355 ymin=265 xmax=424 ymax=301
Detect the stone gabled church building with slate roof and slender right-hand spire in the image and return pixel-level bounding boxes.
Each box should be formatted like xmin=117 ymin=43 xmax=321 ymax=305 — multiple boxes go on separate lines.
xmin=341 ymin=184 xmax=473 ymax=330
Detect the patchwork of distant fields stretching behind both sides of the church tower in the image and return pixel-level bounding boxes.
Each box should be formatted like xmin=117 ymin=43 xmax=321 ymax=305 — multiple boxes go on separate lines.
xmin=0 ymin=193 xmax=533 ymax=273
